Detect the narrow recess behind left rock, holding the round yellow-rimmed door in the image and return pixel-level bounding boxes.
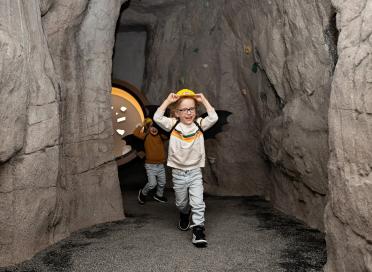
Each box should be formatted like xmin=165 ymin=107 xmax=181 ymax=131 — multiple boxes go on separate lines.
xmin=112 ymin=4 xmax=152 ymax=192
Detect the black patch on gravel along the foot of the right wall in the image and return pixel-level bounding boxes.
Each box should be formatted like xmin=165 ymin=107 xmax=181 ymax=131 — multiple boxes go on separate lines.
xmin=240 ymin=197 xmax=327 ymax=272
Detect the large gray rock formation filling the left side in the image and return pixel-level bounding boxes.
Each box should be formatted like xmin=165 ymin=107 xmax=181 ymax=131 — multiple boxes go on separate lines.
xmin=0 ymin=0 xmax=123 ymax=266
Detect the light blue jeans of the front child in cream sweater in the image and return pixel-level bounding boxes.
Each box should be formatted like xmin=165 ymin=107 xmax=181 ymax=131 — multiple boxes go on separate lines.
xmin=172 ymin=168 xmax=205 ymax=227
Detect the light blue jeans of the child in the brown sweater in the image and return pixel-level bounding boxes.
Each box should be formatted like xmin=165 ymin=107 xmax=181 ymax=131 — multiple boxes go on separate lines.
xmin=142 ymin=163 xmax=166 ymax=196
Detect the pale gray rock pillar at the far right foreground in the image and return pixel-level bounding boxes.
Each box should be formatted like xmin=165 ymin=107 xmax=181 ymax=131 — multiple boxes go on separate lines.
xmin=325 ymin=0 xmax=372 ymax=272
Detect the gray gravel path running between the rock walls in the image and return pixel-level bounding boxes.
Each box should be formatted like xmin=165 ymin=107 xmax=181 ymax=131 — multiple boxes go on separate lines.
xmin=0 ymin=191 xmax=326 ymax=272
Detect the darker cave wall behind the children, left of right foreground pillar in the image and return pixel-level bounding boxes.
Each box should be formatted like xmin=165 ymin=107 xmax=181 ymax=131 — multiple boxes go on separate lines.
xmin=121 ymin=0 xmax=337 ymax=229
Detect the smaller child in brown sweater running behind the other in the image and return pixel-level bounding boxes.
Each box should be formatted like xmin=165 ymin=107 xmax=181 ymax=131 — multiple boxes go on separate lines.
xmin=133 ymin=118 xmax=167 ymax=205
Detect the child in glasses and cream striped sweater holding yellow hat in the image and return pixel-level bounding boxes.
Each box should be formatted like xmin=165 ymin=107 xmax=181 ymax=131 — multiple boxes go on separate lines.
xmin=154 ymin=89 xmax=218 ymax=247
